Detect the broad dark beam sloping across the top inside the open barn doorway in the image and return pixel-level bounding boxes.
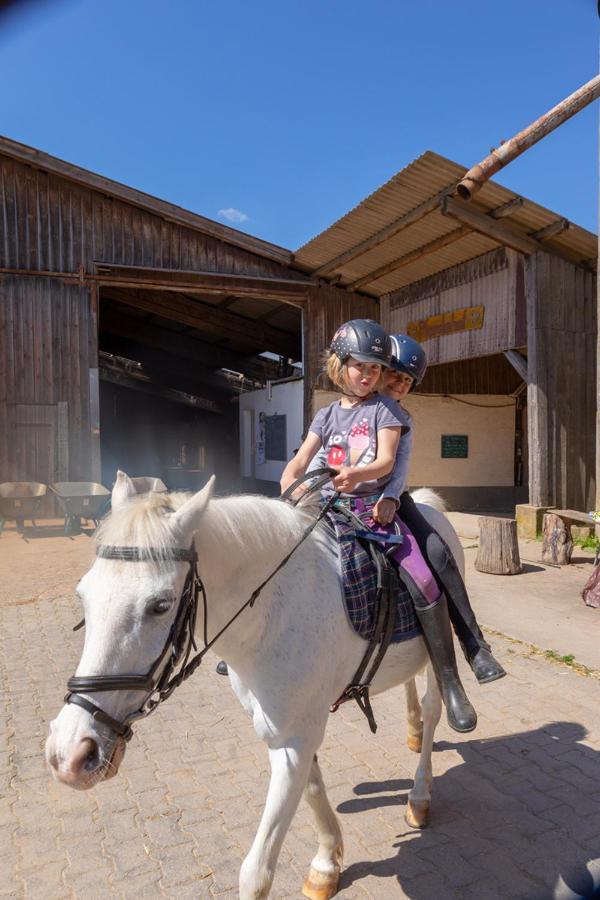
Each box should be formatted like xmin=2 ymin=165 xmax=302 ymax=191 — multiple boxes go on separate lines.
xmin=102 ymin=287 xmax=300 ymax=357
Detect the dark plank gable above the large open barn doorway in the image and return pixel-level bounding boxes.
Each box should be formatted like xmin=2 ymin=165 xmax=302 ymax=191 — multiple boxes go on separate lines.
xmin=0 ymin=155 xmax=298 ymax=277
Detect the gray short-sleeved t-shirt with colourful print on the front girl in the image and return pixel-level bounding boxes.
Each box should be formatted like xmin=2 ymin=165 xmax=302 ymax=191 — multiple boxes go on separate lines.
xmin=309 ymin=395 xmax=405 ymax=497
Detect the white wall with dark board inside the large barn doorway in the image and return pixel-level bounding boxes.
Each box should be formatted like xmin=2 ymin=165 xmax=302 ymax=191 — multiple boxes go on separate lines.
xmin=240 ymin=378 xmax=304 ymax=482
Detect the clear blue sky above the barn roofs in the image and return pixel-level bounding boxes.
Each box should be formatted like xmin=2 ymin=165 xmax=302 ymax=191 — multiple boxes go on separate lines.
xmin=0 ymin=0 xmax=598 ymax=249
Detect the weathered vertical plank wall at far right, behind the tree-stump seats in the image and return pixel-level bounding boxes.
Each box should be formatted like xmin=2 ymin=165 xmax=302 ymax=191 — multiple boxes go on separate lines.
xmin=525 ymin=253 xmax=597 ymax=511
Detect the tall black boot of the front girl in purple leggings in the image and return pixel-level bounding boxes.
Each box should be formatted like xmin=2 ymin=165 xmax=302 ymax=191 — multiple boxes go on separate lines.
xmin=415 ymin=594 xmax=477 ymax=733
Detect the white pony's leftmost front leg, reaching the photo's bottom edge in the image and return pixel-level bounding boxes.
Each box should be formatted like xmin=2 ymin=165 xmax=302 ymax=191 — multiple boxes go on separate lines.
xmin=240 ymin=744 xmax=315 ymax=900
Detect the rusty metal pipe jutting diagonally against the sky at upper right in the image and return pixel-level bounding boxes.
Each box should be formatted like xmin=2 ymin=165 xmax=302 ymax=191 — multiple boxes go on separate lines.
xmin=456 ymin=75 xmax=600 ymax=200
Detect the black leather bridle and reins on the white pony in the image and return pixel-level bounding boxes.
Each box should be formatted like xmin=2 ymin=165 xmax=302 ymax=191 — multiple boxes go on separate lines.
xmin=64 ymin=468 xmax=338 ymax=741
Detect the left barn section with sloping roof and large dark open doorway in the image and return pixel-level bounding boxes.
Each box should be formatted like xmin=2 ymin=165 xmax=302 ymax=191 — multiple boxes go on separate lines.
xmin=0 ymin=138 xmax=376 ymax=511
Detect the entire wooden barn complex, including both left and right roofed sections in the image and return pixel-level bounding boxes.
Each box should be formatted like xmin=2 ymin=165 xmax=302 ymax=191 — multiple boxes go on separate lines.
xmin=0 ymin=138 xmax=597 ymax=511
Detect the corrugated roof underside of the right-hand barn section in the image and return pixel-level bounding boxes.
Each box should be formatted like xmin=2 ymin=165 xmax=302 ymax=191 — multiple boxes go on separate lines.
xmin=294 ymin=150 xmax=598 ymax=297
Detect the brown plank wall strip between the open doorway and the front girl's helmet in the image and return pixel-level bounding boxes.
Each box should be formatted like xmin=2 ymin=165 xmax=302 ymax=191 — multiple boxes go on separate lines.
xmin=302 ymin=285 xmax=379 ymax=429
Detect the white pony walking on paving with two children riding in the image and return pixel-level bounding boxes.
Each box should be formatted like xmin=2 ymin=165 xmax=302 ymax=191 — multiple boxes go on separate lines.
xmin=46 ymin=473 xmax=464 ymax=900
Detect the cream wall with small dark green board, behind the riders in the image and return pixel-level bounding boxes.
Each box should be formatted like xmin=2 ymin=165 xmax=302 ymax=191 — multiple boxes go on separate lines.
xmin=313 ymin=391 xmax=515 ymax=487
